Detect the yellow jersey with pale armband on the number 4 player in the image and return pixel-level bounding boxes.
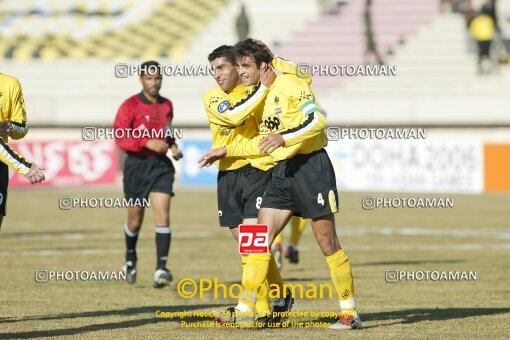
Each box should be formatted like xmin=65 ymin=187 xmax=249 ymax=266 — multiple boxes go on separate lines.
xmin=227 ymin=74 xmax=327 ymax=161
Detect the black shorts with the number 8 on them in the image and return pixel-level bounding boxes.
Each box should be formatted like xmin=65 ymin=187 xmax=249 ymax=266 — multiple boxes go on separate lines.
xmin=218 ymin=165 xmax=271 ymax=227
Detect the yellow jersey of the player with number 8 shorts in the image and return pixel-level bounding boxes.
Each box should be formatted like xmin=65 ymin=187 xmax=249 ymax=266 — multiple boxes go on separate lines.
xmin=203 ymin=57 xmax=311 ymax=171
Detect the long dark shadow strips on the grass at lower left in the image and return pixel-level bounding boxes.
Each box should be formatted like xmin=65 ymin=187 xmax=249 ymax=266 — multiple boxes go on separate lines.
xmin=0 ymin=304 xmax=229 ymax=339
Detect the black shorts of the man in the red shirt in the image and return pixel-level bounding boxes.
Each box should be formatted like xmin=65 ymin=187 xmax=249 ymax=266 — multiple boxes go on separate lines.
xmin=123 ymin=156 xmax=175 ymax=199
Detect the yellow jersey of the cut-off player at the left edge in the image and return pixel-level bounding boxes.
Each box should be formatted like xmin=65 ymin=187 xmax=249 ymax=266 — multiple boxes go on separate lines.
xmin=0 ymin=73 xmax=32 ymax=175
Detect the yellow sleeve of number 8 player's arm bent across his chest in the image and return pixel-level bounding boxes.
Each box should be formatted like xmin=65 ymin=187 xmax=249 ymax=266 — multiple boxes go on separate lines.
xmin=204 ymin=83 xmax=268 ymax=127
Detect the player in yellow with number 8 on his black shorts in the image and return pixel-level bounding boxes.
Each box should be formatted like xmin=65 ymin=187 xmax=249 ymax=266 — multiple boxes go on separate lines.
xmin=203 ymin=45 xmax=311 ymax=321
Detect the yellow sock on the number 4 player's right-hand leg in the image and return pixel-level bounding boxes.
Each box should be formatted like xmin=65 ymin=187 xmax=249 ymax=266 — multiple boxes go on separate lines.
xmin=326 ymin=249 xmax=356 ymax=314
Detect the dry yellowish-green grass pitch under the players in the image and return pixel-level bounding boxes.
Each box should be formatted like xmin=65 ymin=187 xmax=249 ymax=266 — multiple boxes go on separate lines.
xmin=0 ymin=190 xmax=510 ymax=339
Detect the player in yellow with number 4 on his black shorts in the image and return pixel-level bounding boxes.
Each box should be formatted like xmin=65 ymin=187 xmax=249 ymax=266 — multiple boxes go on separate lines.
xmin=201 ymin=39 xmax=362 ymax=329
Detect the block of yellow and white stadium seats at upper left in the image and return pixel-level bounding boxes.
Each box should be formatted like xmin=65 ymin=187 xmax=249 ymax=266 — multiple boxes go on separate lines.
xmin=0 ymin=0 xmax=228 ymax=60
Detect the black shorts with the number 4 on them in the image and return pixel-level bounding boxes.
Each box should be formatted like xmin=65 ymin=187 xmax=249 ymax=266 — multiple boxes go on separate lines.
xmin=262 ymin=149 xmax=338 ymax=218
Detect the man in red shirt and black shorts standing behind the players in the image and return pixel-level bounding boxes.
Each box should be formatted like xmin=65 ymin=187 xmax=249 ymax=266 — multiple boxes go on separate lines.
xmin=113 ymin=61 xmax=182 ymax=288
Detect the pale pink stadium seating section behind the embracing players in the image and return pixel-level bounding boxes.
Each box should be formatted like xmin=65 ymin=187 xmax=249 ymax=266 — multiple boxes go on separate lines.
xmin=278 ymin=0 xmax=439 ymax=88
